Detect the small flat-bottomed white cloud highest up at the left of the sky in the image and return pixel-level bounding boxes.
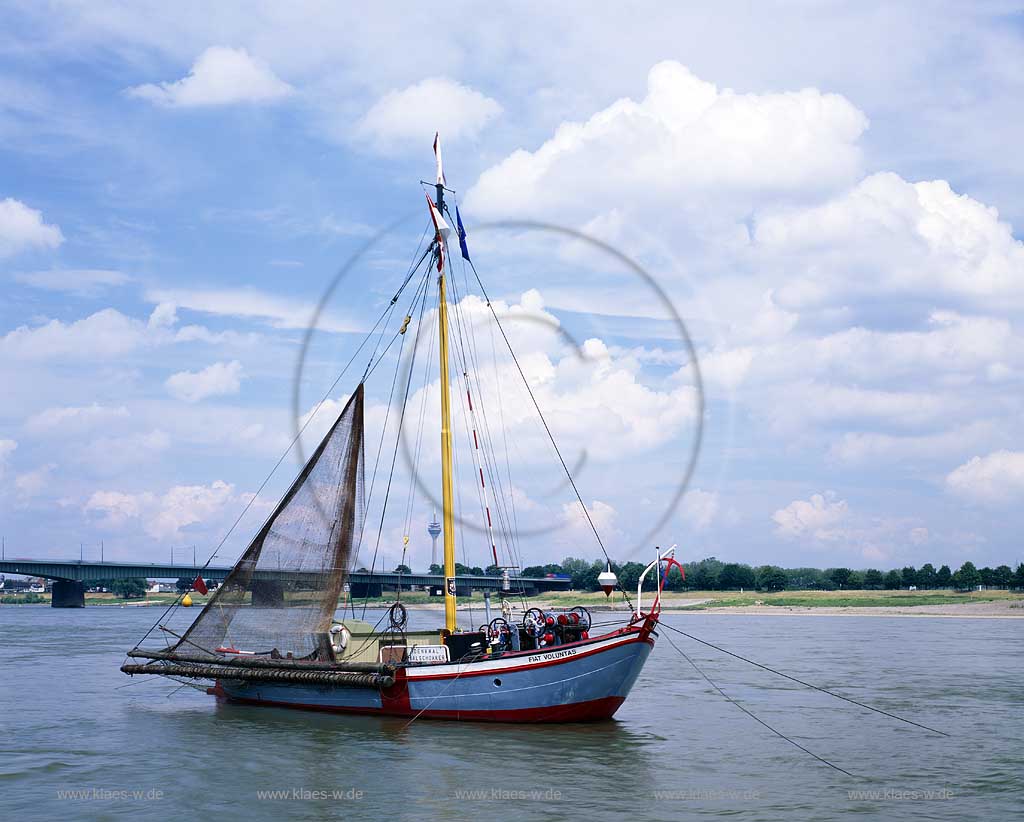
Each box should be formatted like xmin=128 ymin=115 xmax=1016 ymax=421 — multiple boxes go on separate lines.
xmin=127 ymin=46 xmax=295 ymax=107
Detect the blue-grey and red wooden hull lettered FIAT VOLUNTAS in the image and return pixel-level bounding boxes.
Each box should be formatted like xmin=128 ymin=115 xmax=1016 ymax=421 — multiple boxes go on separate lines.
xmin=211 ymin=626 xmax=656 ymax=723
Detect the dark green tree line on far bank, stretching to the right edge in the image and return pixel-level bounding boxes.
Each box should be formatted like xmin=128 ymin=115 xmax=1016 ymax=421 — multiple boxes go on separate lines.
xmin=516 ymin=557 xmax=1024 ymax=592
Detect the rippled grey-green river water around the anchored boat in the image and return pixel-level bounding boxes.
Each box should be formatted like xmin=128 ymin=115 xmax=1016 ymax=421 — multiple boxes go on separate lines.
xmin=0 ymin=606 xmax=1024 ymax=822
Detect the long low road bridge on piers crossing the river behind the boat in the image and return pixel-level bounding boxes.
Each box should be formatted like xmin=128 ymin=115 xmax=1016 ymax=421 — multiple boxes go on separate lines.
xmin=0 ymin=559 xmax=569 ymax=608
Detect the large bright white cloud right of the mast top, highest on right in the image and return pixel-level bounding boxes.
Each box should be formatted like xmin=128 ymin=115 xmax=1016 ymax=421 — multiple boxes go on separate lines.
xmin=466 ymin=60 xmax=867 ymax=218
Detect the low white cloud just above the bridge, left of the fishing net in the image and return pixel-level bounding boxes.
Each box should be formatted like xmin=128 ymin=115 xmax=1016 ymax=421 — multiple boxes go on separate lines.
xmin=83 ymin=480 xmax=237 ymax=539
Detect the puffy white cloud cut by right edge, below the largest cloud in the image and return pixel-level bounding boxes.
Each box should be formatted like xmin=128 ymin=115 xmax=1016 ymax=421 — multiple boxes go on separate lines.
xmin=755 ymin=172 xmax=1024 ymax=308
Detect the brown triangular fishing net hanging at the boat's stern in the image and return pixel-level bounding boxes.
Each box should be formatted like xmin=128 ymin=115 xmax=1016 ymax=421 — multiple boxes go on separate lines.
xmin=174 ymin=384 xmax=365 ymax=659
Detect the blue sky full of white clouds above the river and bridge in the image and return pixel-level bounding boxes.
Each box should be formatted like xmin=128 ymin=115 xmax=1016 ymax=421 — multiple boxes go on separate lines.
xmin=0 ymin=2 xmax=1024 ymax=568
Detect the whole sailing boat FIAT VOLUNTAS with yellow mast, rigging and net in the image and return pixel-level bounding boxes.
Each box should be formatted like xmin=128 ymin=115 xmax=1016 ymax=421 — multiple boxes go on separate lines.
xmin=121 ymin=136 xmax=682 ymax=723
